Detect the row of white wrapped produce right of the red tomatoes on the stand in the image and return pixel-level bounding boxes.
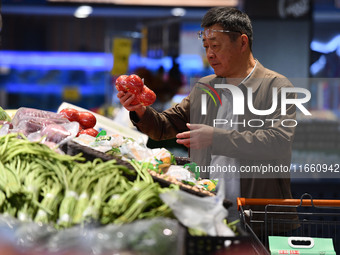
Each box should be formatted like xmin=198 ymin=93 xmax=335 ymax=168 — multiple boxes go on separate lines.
xmin=71 ymin=134 xmax=217 ymax=196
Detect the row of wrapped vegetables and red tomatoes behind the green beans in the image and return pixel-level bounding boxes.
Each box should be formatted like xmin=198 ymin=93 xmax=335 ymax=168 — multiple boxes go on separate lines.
xmin=0 ymin=105 xmax=217 ymax=196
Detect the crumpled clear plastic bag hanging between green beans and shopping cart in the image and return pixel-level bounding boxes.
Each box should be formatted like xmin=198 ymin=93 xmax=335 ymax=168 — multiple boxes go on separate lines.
xmin=160 ymin=182 xmax=235 ymax=236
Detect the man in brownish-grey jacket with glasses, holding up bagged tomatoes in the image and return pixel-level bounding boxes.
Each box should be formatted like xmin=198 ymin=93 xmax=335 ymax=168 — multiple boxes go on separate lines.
xmin=117 ymin=7 xmax=295 ymax=225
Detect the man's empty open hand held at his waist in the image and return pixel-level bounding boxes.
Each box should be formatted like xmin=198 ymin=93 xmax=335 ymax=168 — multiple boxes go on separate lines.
xmin=176 ymin=123 xmax=214 ymax=149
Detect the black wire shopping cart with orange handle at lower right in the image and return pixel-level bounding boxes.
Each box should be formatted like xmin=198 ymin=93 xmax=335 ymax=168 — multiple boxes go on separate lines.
xmin=237 ymin=193 xmax=340 ymax=254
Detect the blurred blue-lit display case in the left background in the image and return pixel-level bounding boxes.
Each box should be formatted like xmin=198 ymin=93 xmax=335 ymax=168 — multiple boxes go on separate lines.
xmin=0 ymin=51 xmax=112 ymax=111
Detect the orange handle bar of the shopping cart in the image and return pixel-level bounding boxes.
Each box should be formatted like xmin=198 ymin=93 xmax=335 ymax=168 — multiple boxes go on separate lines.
xmin=237 ymin=197 xmax=340 ymax=211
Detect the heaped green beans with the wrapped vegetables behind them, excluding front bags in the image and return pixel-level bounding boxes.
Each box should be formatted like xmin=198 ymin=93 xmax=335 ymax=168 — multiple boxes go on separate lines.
xmin=0 ymin=106 xmax=223 ymax=227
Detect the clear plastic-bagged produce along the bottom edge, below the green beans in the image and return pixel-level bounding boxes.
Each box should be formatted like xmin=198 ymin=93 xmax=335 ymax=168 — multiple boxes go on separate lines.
xmin=0 ymin=216 xmax=185 ymax=255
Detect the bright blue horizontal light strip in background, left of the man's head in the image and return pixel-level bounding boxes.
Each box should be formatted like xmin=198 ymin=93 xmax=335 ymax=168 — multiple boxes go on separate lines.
xmin=0 ymin=51 xmax=203 ymax=74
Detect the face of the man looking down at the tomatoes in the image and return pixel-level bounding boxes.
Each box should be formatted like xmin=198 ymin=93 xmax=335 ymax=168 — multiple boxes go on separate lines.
xmin=203 ymin=24 xmax=241 ymax=78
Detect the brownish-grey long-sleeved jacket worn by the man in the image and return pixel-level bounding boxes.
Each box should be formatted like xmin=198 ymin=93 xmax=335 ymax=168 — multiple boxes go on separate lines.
xmin=130 ymin=62 xmax=296 ymax=205
